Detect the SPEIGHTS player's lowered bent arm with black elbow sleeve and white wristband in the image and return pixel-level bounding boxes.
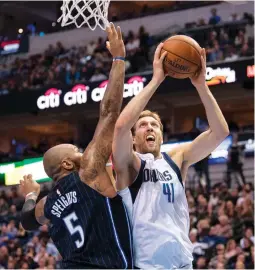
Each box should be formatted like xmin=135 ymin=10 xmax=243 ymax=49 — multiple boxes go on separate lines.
xmin=20 ymin=174 xmax=49 ymax=231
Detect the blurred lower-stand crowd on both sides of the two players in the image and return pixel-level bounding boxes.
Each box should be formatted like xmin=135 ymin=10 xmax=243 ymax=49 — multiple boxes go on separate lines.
xmin=0 ymin=174 xmax=254 ymax=269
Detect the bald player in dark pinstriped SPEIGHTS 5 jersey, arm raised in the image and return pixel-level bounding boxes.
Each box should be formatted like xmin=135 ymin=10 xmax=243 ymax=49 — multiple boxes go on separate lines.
xmin=20 ymin=24 xmax=133 ymax=269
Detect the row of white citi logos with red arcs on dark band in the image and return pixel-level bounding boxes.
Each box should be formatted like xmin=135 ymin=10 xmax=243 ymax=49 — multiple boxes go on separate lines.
xmin=37 ymin=76 xmax=146 ymax=110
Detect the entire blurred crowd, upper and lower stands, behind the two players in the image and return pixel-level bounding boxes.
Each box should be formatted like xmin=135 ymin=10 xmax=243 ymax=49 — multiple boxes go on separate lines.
xmin=0 ymin=1 xmax=254 ymax=269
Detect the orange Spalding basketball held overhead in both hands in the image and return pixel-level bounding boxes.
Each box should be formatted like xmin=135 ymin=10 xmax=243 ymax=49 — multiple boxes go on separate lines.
xmin=161 ymin=35 xmax=201 ymax=79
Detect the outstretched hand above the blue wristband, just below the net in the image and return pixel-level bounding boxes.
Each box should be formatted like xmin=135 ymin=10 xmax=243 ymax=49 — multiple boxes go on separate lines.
xmin=106 ymin=23 xmax=126 ymax=57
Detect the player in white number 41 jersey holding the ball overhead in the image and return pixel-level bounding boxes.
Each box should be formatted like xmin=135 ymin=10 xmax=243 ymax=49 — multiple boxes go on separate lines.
xmin=113 ymin=44 xmax=229 ymax=269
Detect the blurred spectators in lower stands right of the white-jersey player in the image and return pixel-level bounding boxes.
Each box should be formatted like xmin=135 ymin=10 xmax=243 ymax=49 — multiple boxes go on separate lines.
xmin=189 ymin=184 xmax=254 ymax=269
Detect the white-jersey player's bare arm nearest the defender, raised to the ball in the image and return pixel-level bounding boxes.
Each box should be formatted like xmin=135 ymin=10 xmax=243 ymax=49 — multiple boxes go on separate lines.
xmin=113 ymin=43 xmax=166 ymax=190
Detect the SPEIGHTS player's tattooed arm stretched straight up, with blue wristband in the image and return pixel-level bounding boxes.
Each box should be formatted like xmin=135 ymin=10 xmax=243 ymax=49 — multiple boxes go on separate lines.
xmin=79 ymin=23 xmax=126 ymax=197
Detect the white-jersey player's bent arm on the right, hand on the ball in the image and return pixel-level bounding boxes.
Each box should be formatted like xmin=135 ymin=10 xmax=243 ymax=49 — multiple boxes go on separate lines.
xmin=171 ymin=49 xmax=229 ymax=169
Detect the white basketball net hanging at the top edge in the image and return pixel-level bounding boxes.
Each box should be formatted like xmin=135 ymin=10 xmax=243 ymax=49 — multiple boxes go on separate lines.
xmin=57 ymin=0 xmax=110 ymax=31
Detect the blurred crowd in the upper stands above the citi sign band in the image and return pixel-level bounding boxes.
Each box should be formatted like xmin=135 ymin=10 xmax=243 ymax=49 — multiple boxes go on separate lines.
xmin=0 ymin=9 xmax=254 ymax=94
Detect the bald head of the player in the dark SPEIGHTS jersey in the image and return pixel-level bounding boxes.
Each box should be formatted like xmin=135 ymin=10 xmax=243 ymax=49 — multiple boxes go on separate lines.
xmin=43 ymin=144 xmax=81 ymax=180
